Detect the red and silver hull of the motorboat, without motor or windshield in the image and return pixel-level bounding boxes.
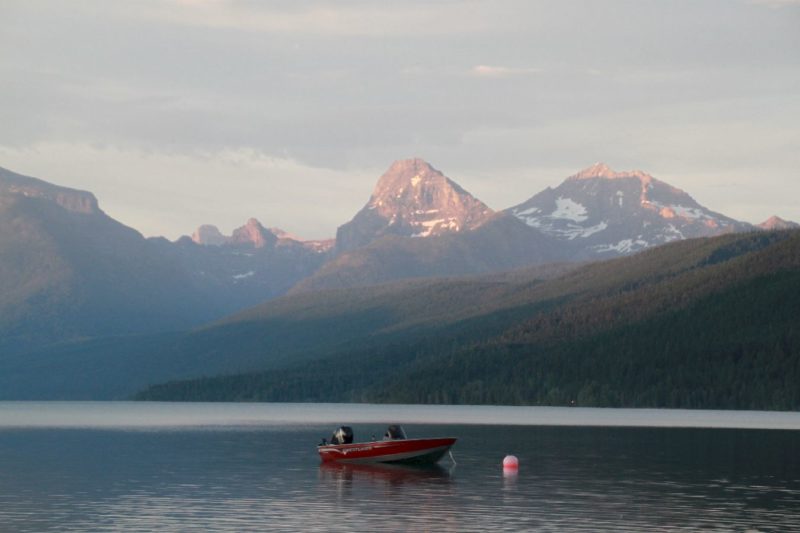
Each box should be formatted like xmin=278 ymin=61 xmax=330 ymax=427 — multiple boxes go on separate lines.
xmin=317 ymin=437 xmax=456 ymax=464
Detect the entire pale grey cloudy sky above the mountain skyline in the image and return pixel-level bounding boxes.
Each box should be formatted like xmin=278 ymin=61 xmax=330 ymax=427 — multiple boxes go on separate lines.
xmin=0 ymin=0 xmax=800 ymax=239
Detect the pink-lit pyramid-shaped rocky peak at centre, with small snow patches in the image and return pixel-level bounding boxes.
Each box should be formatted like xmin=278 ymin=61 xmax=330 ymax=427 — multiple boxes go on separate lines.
xmin=336 ymin=159 xmax=493 ymax=253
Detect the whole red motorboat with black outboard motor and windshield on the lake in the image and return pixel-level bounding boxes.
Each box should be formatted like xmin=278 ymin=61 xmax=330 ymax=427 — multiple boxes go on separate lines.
xmin=317 ymin=425 xmax=456 ymax=464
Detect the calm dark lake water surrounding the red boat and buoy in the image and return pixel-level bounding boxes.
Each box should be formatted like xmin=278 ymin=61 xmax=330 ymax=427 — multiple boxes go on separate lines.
xmin=0 ymin=402 xmax=800 ymax=532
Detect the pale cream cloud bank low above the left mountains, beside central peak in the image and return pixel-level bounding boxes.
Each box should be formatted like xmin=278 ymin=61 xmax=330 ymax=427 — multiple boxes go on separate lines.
xmin=0 ymin=142 xmax=380 ymax=239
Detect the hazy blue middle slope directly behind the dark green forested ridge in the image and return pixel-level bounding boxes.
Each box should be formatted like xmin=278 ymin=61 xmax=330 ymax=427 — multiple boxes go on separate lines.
xmin=0 ymin=258 xmax=576 ymax=400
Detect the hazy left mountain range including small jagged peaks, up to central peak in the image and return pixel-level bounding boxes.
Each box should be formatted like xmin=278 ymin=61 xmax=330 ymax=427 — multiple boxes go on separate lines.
xmin=0 ymin=164 xmax=332 ymax=353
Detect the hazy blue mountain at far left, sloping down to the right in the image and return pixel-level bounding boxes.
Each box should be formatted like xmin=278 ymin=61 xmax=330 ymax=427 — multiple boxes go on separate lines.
xmin=0 ymin=164 xmax=215 ymax=353
